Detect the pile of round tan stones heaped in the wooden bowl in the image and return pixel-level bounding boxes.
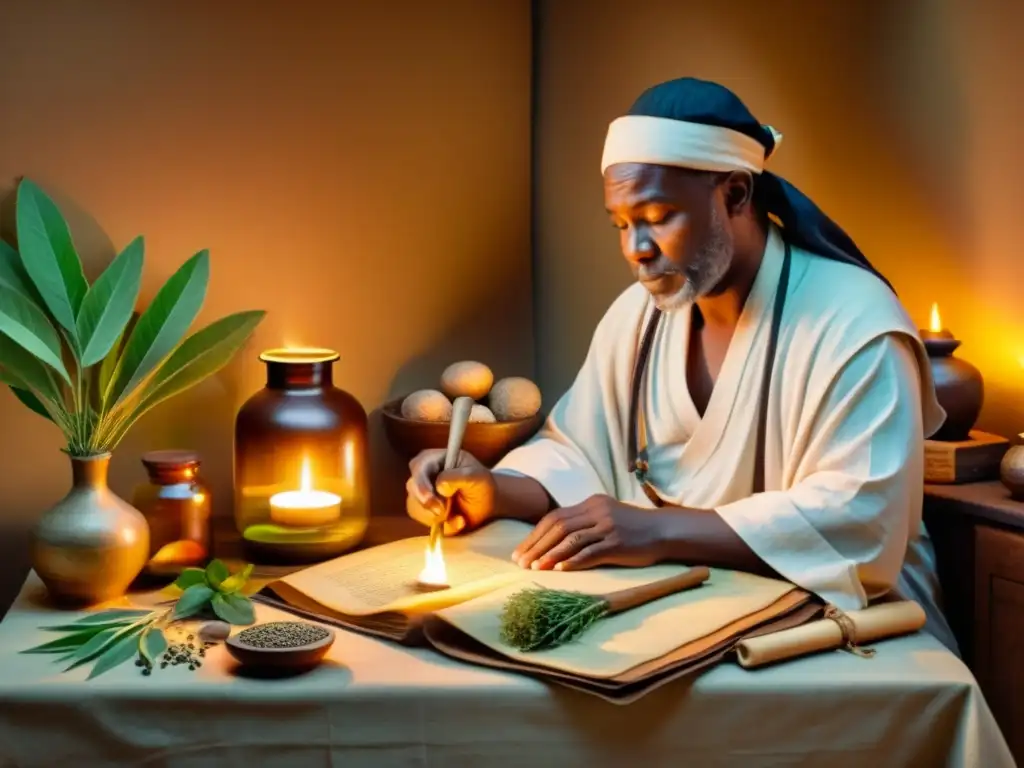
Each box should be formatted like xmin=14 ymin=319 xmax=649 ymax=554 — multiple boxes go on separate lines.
xmin=401 ymin=360 xmax=541 ymax=424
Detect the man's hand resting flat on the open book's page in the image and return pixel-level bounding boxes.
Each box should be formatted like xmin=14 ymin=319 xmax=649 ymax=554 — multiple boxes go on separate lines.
xmin=512 ymin=496 xmax=662 ymax=570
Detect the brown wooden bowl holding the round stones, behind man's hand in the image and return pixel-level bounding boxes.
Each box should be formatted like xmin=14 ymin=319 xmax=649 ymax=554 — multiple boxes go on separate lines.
xmin=381 ymin=397 xmax=544 ymax=467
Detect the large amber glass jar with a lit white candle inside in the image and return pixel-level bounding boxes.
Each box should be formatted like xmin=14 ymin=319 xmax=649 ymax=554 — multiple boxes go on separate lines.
xmin=234 ymin=349 xmax=370 ymax=563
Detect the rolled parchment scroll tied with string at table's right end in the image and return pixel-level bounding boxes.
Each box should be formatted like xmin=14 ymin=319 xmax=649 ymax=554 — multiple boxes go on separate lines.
xmin=736 ymin=600 xmax=925 ymax=669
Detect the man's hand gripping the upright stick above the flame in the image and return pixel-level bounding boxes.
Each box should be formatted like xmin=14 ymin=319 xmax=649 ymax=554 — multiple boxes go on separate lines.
xmin=406 ymin=450 xmax=497 ymax=536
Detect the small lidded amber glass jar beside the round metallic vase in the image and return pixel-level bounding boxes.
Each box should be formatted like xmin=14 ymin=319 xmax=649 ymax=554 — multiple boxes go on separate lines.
xmin=132 ymin=451 xmax=211 ymax=580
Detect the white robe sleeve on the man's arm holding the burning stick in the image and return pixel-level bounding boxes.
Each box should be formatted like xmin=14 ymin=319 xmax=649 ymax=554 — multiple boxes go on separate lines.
xmin=494 ymin=301 xmax=624 ymax=507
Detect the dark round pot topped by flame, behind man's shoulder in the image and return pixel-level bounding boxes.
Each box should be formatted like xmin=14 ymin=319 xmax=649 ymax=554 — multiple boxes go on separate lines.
xmin=925 ymin=339 xmax=984 ymax=442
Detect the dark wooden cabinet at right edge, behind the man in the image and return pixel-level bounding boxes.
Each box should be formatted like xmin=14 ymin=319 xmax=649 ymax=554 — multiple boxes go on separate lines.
xmin=925 ymin=480 xmax=1024 ymax=763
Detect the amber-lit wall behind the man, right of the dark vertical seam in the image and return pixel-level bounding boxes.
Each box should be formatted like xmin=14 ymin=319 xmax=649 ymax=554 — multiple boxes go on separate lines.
xmin=535 ymin=0 xmax=1024 ymax=435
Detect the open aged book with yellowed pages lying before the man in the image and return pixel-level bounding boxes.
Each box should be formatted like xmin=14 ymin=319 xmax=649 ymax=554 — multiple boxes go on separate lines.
xmin=255 ymin=520 xmax=821 ymax=702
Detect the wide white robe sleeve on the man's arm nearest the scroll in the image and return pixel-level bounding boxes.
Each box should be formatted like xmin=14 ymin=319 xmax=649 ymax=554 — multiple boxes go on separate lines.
xmin=717 ymin=334 xmax=924 ymax=610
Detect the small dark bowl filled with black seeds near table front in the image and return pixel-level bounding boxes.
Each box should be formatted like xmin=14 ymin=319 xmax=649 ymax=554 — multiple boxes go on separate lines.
xmin=224 ymin=622 xmax=334 ymax=672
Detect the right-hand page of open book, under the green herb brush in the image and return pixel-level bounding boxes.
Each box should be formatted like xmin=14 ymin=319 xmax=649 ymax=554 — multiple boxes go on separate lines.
xmin=437 ymin=565 xmax=796 ymax=679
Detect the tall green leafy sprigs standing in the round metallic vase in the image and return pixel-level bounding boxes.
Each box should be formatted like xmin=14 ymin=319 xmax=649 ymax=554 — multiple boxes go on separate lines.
xmin=0 ymin=179 xmax=265 ymax=457
